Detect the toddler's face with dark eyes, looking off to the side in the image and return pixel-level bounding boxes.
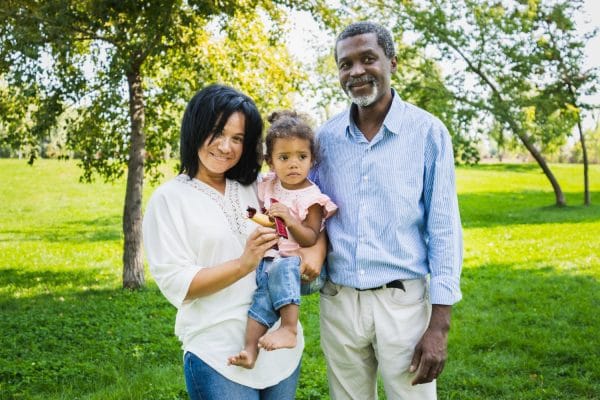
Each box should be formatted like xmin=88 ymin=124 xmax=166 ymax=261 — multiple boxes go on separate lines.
xmin=269 ymin=137 xmax=312 ymax=190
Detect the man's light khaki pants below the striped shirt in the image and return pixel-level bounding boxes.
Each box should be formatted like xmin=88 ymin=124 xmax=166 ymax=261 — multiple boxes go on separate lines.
xmin=321 ymin=279 xmax=437 ymax=400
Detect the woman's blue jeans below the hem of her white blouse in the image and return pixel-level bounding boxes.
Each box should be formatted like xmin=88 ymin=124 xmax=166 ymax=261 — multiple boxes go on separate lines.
xmin=183 ymin=352 xmax=300 ymax=400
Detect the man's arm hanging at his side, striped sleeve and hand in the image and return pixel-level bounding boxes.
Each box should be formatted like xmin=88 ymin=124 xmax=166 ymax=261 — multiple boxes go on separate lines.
xmin=409 ymin=125 xmax=462 ymax=385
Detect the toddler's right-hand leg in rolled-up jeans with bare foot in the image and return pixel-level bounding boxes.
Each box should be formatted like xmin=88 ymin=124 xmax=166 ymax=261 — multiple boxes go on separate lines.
xmin=258 ymin=257 xmax=300 ymax=350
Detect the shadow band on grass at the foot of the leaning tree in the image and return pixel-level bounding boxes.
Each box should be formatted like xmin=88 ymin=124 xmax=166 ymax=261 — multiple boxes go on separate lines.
xmin=458 ymin=191 xmax=600 ymax=228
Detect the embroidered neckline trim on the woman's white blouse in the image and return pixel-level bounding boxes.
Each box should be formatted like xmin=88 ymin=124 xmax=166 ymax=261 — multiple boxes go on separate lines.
xmin=175 ymin=174 xmax=246 ymax=235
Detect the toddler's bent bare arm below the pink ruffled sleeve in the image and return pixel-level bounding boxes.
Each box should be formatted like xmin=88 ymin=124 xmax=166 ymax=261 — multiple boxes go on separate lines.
xmin=269 ymin=203 xmax=323 ymax=247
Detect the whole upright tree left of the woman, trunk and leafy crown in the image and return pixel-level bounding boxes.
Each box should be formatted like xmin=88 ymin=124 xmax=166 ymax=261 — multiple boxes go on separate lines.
xmin=0 ymin=0 xmax=333 ymax=289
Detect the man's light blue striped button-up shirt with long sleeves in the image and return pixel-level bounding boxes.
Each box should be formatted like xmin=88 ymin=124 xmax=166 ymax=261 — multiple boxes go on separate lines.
xmin=311 ymin=91 xmax=462 ymax=304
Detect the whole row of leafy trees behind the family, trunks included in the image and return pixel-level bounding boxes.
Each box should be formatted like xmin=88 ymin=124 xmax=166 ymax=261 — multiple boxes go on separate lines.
xmin=0 ymin=0 xmax=598 ymax=288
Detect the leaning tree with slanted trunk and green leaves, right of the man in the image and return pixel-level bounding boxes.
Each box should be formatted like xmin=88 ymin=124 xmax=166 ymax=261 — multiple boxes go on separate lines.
xmin=352 ymin=0 xmax=596 ymax=206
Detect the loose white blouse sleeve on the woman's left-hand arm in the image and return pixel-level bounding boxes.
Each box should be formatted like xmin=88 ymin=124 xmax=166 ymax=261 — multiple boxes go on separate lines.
xmin=142 ymin=191 xmax=202 ymax=308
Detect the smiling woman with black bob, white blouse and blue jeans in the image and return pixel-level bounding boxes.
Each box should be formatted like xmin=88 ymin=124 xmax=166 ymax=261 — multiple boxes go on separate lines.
xmin=143 ymin=85 xmax=324 ymax=399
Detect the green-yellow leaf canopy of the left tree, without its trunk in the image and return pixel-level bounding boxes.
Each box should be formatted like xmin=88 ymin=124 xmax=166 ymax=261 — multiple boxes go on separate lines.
xmin=0 ymin=0 xmax=318 ymax=180
